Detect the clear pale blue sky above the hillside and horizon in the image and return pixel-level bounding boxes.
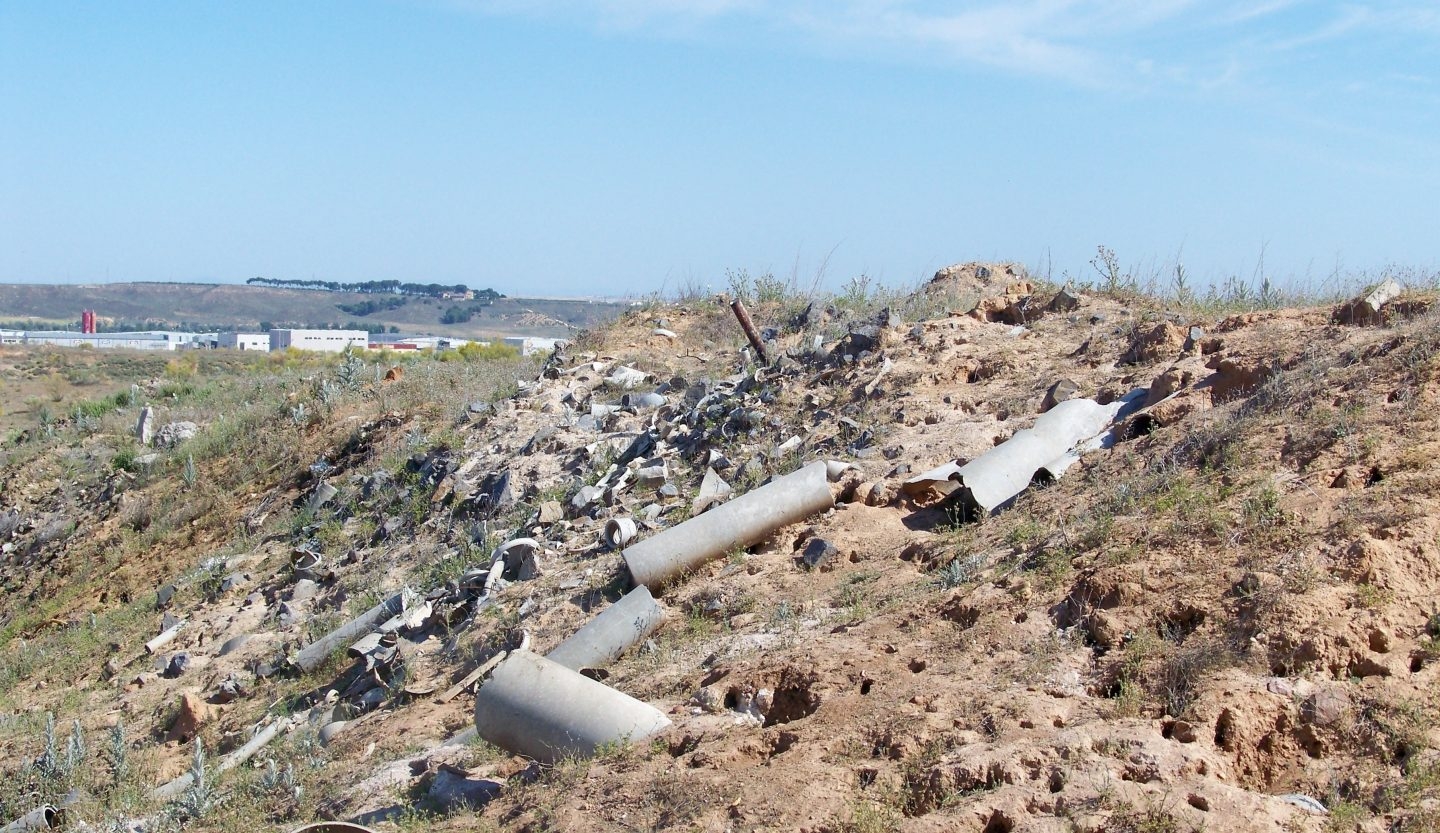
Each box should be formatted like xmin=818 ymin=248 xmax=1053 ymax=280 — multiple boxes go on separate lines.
xmin=0 ymin=0 xmax=1440 ymax=295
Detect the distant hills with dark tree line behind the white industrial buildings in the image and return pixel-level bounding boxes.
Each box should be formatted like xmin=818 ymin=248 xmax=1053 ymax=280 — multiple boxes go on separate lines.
xmin=0 ymin=282 xmax=626 ymax=337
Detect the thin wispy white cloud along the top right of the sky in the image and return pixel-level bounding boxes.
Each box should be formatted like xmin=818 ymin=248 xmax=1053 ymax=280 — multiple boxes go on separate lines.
xmin=449 ymin=0 xmax=1440 ymax=89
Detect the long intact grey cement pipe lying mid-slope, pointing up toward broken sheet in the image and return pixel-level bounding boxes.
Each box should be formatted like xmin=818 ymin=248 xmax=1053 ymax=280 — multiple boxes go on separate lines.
xmin=625 ymin=461 xmax=835 ymax=589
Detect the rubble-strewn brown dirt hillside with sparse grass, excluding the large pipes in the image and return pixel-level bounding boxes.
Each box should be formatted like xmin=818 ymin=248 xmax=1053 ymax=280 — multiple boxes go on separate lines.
xmin=0 ymin=264 xmax=1440 ymax=833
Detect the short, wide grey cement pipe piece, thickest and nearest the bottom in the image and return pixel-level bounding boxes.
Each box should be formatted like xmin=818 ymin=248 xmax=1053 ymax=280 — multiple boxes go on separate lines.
xmin=475 ymin=651 xmax=670 ymax=764
